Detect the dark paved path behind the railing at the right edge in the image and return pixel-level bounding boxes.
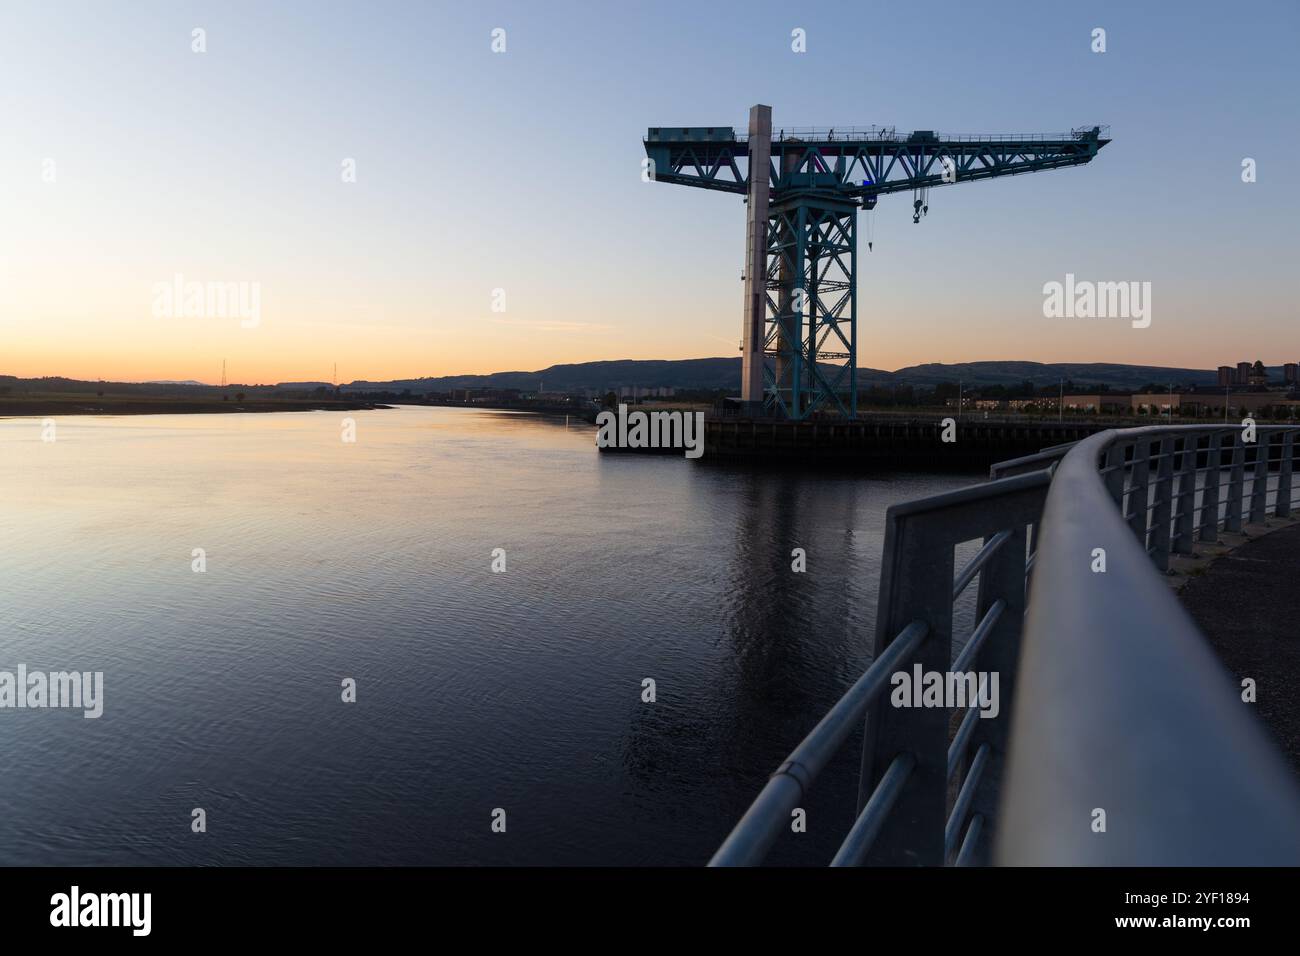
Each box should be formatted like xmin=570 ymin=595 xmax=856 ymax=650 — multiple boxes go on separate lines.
xmin=1179 ymin=524 xmax=1300 ymax=775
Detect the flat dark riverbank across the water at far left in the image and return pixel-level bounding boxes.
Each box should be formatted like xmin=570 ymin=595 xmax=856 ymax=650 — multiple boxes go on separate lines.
xmin=0 ymin=393 xmax=393 ymax=418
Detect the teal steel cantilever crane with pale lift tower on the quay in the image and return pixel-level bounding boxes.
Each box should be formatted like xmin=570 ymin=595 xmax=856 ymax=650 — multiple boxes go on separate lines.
xmin=645 ymin=105 xmax=1110 ymax=419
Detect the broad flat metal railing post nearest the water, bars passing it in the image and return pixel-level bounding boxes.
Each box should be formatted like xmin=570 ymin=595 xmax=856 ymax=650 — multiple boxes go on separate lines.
xmin=857 ymin=514 xmax=951 ymax=866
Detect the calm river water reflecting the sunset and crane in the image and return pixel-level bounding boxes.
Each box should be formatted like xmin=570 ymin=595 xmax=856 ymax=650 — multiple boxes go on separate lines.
xmin=0 ymin=407 xmax=979 ymax=865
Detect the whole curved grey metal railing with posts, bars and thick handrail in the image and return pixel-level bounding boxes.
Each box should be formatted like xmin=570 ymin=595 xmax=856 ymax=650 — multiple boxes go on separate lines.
xmin=711 ymin=425 xmax=1300 ymax=866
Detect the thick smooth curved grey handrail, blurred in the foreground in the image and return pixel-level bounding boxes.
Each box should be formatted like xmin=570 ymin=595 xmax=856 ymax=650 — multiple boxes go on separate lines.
xmin=996 ymin=425 xmax=1300 ymax=866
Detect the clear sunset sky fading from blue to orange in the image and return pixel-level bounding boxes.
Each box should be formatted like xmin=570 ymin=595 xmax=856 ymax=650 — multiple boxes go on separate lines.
xmin=0 ymin=0 xmax=1300 ymax=382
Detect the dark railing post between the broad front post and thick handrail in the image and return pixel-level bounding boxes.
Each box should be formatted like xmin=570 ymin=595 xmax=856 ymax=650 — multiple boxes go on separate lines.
xmin=958 ymin=522 xmax=1029 ymax=866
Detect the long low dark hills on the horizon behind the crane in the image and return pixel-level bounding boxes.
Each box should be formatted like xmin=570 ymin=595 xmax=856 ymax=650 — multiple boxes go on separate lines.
xmin=338 ymin=358 xmax=1282 ymax=393
